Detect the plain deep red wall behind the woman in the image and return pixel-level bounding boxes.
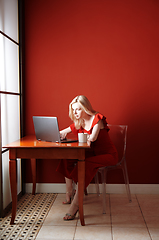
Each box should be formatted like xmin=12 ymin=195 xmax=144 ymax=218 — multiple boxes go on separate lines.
xmin=25 ymin=0 xmax=159 ymax=184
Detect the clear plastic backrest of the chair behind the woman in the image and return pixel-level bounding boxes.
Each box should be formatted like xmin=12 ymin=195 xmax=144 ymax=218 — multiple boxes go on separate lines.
xmin=108 ymin=124 xmax=128 ymax=163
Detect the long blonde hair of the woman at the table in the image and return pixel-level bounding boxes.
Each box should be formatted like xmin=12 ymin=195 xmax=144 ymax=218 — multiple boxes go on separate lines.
xmin=69 ymin=95 xmax=97 ymax=129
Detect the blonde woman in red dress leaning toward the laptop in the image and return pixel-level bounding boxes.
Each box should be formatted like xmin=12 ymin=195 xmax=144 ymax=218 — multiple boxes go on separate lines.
xmin=57 ymin=95 xmax=118 ymax=220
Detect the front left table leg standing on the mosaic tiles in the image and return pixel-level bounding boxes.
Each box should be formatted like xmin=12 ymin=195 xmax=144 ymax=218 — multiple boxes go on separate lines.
xmin=9 ymin=159 xmax=17 ymax=224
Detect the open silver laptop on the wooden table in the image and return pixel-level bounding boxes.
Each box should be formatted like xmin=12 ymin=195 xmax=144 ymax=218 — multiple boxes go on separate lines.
xmin=33 ymin=116 xmax=77 ymax=143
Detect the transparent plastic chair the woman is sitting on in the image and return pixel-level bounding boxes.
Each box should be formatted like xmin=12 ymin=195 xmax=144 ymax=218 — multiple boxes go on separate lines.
xmin=95 ymin=124 xmax=131 ymax=214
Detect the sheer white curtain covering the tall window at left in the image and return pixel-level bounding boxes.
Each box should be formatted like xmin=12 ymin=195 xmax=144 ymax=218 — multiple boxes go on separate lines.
xmin=0 ymin=0 xmax=21 ymax=215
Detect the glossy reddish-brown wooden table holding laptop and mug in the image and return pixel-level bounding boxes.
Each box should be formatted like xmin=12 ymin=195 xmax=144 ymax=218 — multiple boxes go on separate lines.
xmin=4 ymin=136 xmax=90 ymax=226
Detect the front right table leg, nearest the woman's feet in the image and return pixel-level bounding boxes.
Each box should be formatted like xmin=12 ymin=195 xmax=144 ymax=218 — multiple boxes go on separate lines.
xmin=78 ymin=161 xmax=85 ymax=226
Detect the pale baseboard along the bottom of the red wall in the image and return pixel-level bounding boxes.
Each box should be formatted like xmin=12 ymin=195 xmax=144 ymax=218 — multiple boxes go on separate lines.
xmin=26 ymin=183 xmax=159 ymax=194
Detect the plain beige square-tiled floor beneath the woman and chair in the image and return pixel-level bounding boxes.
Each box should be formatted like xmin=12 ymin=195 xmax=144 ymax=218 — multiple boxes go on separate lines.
xmin=36 ymin=194 xmax=159 ymax=240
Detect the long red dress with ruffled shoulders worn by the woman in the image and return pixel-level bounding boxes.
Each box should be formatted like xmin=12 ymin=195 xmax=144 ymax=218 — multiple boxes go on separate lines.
xmin=57 ymin=113 xmax=118 ymax=188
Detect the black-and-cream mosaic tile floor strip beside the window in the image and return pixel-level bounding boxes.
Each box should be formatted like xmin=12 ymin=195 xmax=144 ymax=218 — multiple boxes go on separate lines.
xmin=0 ymin=193 xmax=57 ymax=240
